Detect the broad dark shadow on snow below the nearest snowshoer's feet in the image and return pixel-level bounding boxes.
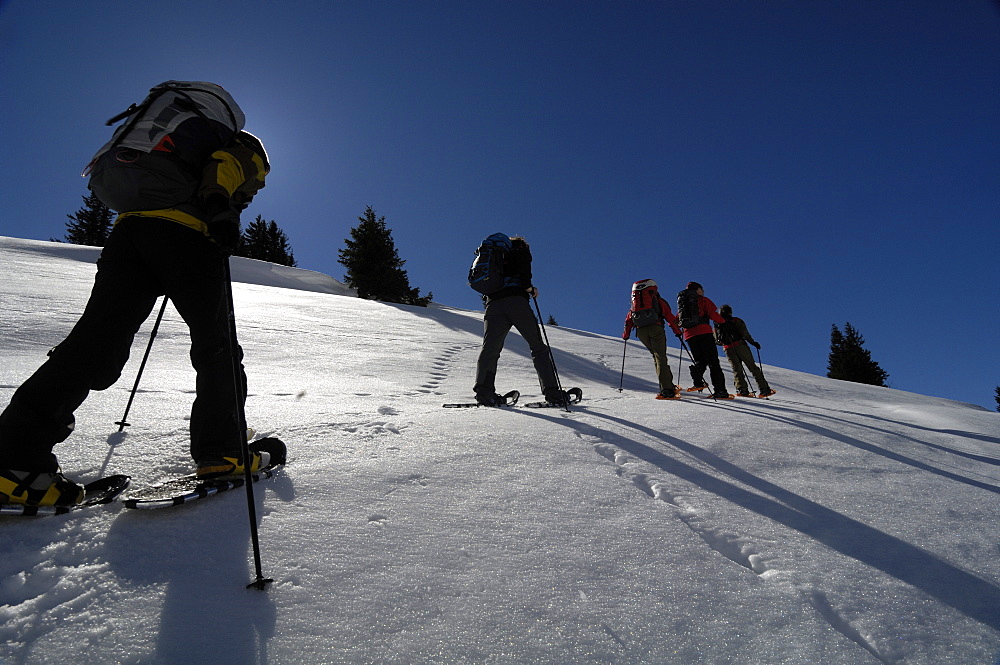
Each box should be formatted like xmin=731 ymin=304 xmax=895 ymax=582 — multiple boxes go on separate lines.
xmin=106 ymin=474 xmax=294 ymax=663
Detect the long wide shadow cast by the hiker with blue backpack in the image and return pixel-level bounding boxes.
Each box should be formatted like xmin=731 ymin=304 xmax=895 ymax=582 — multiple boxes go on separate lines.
xmin=524 ymin=409 xmax=1000 ymax=630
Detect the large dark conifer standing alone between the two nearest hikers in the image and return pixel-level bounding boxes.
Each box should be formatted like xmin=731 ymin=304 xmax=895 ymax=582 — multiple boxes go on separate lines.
xmin=338 ymin=206 xmax=434 ymax=307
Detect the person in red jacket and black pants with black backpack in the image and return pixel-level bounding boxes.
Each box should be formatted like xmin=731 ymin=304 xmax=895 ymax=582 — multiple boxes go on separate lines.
xmin=677 ymin=282 xmax=733 ymax=399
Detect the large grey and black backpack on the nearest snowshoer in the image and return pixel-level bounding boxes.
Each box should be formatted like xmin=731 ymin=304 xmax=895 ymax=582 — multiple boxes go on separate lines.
xmin=82 ymin=81 xmax=246 ymax=212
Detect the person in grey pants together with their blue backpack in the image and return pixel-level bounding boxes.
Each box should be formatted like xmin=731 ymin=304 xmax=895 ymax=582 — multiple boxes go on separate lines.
xmin=469 ymin=233 xmax=569 ymax=406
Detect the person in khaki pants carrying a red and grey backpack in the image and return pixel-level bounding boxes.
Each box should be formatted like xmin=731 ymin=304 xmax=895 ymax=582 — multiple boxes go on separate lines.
xmin=622 ymin=279 xmax=681 ymax=399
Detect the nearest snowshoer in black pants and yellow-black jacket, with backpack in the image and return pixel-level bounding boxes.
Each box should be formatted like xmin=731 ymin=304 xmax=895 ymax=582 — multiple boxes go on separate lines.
xmin=0 ymin=81 xmax=270 ymax=506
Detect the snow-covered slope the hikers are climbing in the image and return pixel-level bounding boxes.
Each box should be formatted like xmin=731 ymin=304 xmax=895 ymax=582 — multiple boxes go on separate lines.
xmin=0 ymin=238 xmax=1000 ymax=665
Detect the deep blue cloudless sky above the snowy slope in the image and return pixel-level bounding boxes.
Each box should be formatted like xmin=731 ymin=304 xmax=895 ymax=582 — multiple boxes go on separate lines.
xmin=0 ymin=0 xmax=1000 ymax=409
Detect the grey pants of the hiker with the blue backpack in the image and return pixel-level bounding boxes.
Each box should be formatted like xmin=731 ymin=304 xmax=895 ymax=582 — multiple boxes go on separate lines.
xmin=473 ymin=296 xmax=557 ymax=395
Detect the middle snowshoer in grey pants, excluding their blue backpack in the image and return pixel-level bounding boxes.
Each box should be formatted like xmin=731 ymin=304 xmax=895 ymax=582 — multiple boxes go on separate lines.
xmin=473 ymin=237 xmax=567 ymax=406
